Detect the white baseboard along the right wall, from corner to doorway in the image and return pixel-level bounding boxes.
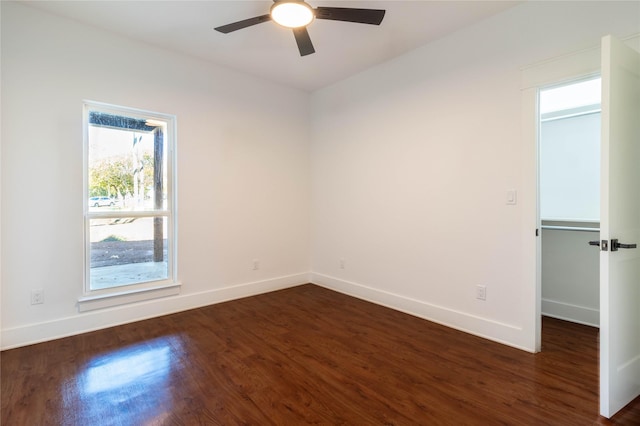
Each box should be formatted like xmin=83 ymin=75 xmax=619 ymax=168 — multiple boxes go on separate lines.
xmin=311 ymin=272 xmax=535 ymax=352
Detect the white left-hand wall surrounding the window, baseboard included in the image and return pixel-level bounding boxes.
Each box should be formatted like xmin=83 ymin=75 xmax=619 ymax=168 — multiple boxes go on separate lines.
xmin=1 ymin=2 xmax=310 ymax=348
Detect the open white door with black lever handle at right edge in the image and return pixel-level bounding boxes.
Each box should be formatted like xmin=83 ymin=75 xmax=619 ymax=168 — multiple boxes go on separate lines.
xmin=600 ymin=36 xmax=640 ymax=417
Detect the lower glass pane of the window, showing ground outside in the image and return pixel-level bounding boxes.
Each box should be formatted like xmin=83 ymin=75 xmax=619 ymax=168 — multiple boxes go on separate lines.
xmin=89 ymin=217 xmax=169 ymax=290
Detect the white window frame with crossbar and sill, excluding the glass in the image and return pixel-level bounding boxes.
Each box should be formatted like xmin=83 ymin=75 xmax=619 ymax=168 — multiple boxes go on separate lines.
xmin=78 ymin=101 xmax=180 ymax=312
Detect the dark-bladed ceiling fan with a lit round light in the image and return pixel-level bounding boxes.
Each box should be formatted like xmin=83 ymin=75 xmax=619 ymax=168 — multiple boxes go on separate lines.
xmin=214 ymin=0 xmax=385 ymax=56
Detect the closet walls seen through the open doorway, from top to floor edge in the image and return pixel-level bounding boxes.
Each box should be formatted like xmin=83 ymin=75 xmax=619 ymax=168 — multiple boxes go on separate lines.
xmin=538 ymin=76 xmax=601 ymax=327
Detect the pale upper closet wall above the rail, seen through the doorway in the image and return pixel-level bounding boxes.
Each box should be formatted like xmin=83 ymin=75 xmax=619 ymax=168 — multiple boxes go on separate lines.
xmin=540 ymin=78 xmax=600 ymax=222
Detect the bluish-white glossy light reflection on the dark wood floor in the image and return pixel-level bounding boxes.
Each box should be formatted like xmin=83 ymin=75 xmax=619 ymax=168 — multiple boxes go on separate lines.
xmin=64 ymin=336 xmax=181 ymax=425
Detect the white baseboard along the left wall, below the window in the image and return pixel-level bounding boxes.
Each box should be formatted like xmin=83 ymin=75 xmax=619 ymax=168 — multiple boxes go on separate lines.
xmin=0 ymin=273 xmax=310 ymax=350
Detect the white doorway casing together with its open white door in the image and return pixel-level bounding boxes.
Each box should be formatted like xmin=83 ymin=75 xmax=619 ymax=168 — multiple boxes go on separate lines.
xmin=522 ymin=35 xmax=640 ymax=418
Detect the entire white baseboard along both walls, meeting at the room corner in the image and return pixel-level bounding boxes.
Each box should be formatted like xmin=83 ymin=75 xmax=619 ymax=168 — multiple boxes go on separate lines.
xmin=0 ymin=273 xmax=534 ymax=352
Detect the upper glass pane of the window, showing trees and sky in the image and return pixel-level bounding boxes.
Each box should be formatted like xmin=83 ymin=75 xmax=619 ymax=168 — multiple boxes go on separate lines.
xmin=88 ymin=116 xmax=167 ymax=212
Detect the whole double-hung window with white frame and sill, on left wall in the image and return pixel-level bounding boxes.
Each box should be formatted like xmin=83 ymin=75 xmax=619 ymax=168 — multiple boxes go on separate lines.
xmin=80 ymin=102 xmax=177 ymax=310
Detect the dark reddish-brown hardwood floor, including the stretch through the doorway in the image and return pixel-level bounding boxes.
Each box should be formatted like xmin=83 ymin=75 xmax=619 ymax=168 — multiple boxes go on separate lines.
xmin=1 ymin=285 xmax=640 ymax=425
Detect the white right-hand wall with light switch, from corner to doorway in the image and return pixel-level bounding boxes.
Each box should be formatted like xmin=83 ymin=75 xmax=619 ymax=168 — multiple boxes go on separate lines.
xmin=312 ymin=2 xmax=640 ymax=350
